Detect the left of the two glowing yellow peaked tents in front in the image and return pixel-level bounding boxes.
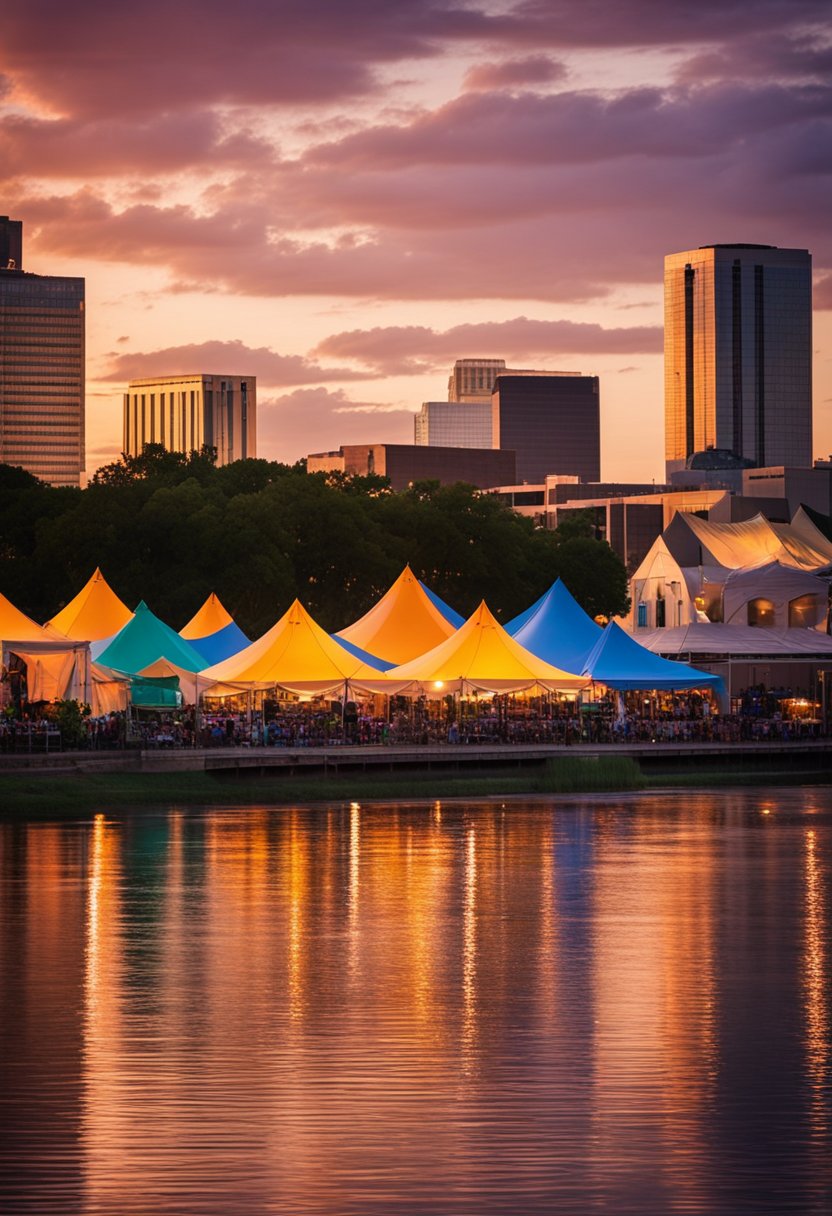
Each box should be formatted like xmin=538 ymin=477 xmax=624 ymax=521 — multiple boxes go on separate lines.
xmin=199 ymin=599 xmax=380 ymax=697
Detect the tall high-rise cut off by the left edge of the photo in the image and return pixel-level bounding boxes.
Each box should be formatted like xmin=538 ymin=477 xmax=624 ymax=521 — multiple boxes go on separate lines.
xmin=0 ymin=215 xmax=84 ymax=485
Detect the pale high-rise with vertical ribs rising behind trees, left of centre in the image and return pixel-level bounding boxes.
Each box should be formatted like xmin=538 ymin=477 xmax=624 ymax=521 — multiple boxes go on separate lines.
xmin=124 ymin=373 xmax=257 ymax=465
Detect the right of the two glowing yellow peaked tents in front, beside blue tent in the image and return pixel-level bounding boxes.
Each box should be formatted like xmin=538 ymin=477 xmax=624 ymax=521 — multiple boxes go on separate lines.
xmin=377 ymin=601 xmax=589 ymax=696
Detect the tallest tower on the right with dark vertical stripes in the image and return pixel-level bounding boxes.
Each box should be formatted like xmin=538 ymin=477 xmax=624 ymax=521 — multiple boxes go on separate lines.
xmin=664 ymin=244 xmax=813 ymax=475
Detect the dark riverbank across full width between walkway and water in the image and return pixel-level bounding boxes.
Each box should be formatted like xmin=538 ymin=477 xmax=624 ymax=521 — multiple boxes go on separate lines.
xmin=0 ymin=755 xmax=830 ymax=816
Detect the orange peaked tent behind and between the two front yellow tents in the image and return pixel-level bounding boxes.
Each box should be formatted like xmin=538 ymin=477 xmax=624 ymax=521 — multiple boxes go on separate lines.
xmin=336 ymin=565 xmax=455 ymax=663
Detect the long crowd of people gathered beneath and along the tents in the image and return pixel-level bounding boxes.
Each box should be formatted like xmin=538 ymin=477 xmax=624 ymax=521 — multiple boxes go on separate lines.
xmin=0 ymin=687 xmax=828 ymax=753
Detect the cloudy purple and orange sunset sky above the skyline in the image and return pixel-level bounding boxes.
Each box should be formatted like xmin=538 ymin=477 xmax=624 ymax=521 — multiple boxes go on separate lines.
xmin=0 ymin=0 xmax=832 ymax=479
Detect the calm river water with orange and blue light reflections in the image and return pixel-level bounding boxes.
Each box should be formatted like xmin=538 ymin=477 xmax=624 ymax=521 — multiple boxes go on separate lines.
xmin=0 ymin=789 xmax=832 ymax=1216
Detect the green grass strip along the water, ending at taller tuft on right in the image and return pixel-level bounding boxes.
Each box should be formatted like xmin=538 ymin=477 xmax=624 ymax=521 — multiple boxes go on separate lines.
xmin=0 ymin=756 xmax=645 ymax=815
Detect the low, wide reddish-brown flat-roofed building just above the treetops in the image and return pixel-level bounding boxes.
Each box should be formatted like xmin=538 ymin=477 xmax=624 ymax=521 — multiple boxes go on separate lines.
xmin=307 ymin=444 xmax=515 ymax=490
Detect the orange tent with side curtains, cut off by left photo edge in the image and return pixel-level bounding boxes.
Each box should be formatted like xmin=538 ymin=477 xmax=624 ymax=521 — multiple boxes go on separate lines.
xmin=0 ymin=593 xmax=90 ymax=703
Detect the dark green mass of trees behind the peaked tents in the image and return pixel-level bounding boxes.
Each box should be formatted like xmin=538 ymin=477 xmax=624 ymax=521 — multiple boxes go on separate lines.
xmin=0 ymin=446 xmax=626 ymax=637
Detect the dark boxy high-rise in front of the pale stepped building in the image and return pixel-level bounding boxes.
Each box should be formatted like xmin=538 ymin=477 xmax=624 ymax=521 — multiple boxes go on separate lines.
xmin=491 ymin=372 xmax=601 ymax=483
